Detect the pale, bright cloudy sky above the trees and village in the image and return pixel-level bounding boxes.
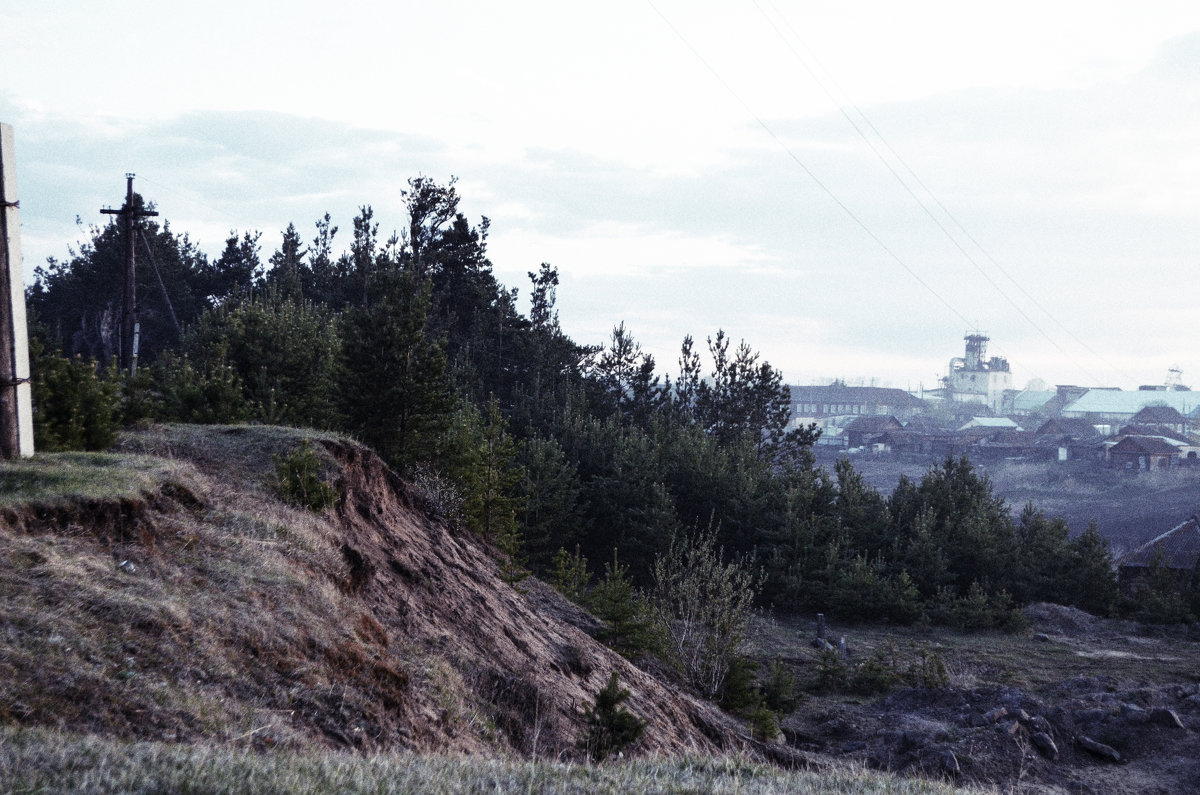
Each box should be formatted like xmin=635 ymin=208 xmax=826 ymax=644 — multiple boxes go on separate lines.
xmin=0 ymin=0 xmax=1200 ymax=390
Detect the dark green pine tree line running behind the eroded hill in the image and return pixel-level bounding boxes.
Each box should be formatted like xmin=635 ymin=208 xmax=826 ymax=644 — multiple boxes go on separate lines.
xmin=26 ymin=177 xmax=1137 ymax=627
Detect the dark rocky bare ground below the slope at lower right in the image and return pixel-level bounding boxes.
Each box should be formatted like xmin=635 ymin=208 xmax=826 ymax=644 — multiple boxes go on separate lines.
xmin=758 ymin=604 xmax=1200 ymax=794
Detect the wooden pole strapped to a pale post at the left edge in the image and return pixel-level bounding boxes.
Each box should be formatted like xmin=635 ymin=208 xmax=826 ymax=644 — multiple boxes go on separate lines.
xmin=0 ymin=122 xmax=34 ymax=459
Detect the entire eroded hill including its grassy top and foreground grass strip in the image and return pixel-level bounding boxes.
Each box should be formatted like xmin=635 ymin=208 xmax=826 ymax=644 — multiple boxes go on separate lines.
xmin=0 ymin=425 xmax=993 ymax=793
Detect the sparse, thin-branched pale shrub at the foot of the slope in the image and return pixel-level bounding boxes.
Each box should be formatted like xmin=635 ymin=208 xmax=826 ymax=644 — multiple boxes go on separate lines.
xmin=653 ymin=530 xmax=760 ymax=698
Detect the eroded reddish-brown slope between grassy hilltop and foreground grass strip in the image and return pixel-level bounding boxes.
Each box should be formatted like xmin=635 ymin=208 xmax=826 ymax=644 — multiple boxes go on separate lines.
xmin=0 ymin=429 xmax=768 ymax=758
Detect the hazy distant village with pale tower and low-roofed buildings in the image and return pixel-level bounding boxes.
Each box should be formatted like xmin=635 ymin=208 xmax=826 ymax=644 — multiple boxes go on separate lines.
xmin=791 ymin=333 xmax=1200 ymax=472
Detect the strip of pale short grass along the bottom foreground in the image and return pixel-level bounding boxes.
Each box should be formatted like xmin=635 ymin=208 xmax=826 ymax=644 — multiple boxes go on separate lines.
xmin=0 ymin=730 xmax=991 ymax=795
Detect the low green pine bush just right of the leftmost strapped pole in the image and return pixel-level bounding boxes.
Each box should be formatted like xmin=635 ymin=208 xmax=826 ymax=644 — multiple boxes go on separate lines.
xmin=31 ymin=340 xmax=121 ymax=453
